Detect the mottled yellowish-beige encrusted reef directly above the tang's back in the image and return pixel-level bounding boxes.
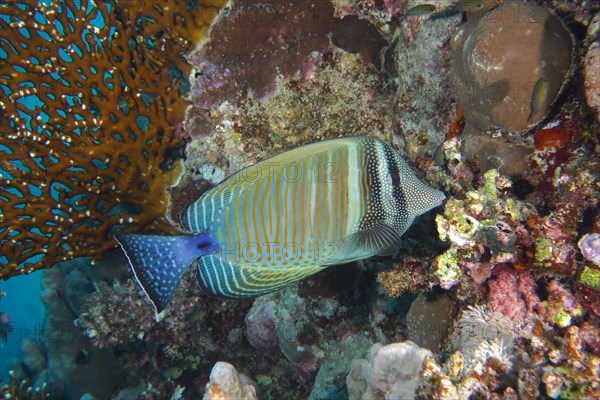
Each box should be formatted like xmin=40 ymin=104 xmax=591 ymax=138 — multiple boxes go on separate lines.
xmin=175 ymin=47 xmax=393 ymax=191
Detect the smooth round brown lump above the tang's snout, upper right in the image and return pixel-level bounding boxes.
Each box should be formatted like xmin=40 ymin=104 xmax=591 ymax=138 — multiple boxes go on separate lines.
xmin=451 ymin=1 xmax=574 ymax=131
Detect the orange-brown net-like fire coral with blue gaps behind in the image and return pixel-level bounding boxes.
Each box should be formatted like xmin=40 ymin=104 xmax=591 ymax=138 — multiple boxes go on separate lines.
xmin=0 ymin=0 xmax=224 ymax=278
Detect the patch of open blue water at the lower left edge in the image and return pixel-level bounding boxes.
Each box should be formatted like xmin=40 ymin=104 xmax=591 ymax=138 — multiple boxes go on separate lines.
xmin=0 ymin=271 xmax=45 ymax=381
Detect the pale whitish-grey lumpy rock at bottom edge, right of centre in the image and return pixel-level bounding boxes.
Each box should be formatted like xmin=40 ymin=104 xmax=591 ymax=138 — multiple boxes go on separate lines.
xmin=346 ymin=340 xmax=432 ymax=400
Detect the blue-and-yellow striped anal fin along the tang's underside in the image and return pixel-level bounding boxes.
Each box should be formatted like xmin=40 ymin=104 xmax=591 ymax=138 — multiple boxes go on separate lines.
xmin=198 ymin=255 xmax=325 ymax=298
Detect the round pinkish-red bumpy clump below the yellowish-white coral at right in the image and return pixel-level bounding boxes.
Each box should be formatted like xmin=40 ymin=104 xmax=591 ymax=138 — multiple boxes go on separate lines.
xmin=488 ymin=271 xmax=540 ymax=320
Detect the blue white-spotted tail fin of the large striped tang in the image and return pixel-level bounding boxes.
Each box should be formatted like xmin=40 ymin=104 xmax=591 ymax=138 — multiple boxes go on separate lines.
xmin=115 ymin=233 xmax=215 ymax=313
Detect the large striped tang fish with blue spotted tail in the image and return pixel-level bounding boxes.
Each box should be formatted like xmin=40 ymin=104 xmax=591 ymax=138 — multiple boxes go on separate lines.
xmin=116 ymin=137 xmax=445 ymax=312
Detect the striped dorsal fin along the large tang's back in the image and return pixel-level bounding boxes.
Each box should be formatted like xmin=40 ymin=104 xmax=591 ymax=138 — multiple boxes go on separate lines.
xmin=181 ymin=137 xmax=364 ymax=232
